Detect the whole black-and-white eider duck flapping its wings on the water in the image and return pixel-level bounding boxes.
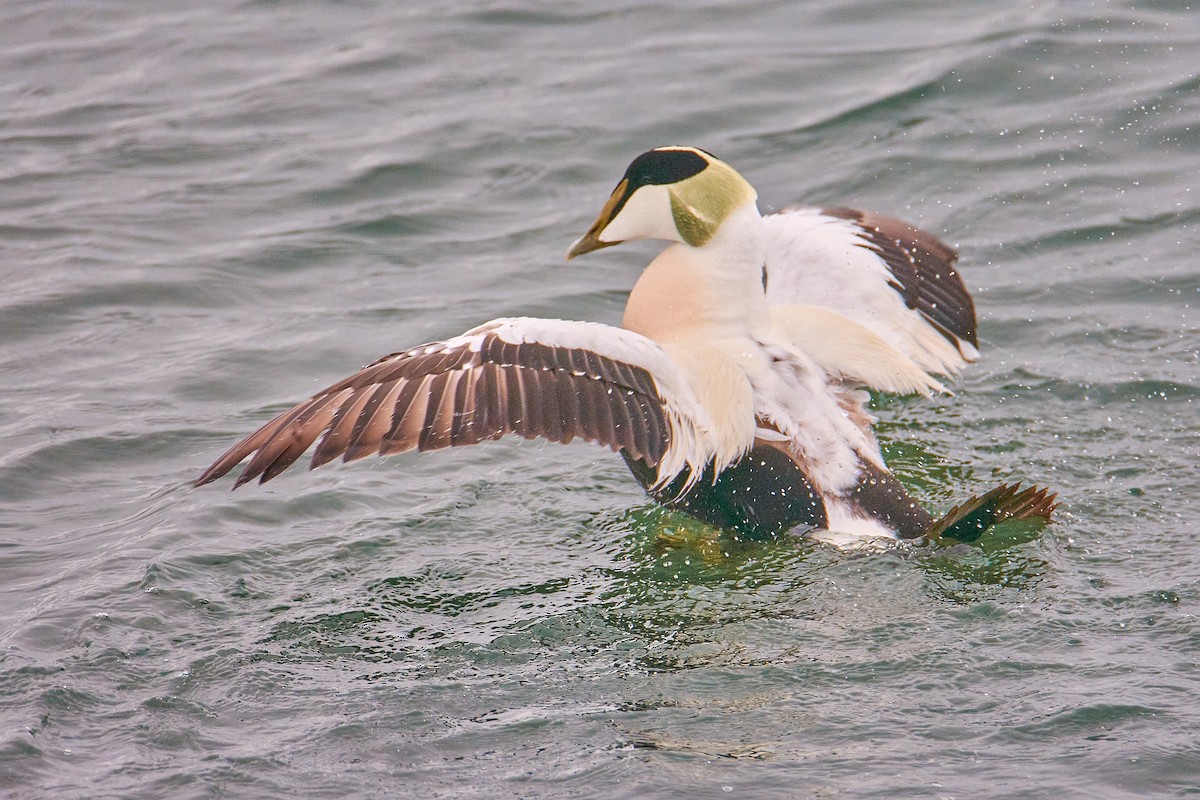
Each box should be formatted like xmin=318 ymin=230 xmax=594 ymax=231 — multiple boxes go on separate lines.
xmin=196 ymin=145 xmax=1057 ymax=542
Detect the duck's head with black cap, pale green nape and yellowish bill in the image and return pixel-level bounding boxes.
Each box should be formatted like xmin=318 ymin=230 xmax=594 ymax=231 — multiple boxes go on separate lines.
xmin=566 ymin=146 xmax=757 ymax=259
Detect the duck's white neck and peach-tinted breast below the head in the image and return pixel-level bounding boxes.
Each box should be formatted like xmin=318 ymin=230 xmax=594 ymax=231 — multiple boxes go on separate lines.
xmin=622 ymin=201 xmax=769 ymax=342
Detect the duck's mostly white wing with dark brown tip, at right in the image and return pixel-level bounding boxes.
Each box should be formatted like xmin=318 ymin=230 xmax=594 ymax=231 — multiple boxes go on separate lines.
xmin=763 ymin=207 xmax=978 ymax=375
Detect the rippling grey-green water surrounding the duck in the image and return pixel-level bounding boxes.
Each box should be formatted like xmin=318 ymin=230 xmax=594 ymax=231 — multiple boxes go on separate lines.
xmin=0 ymin=0 xmax=1200 ymax=798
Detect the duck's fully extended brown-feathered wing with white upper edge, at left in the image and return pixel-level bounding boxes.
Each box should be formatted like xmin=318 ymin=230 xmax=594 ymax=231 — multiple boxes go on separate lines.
xmin=196 ymin=318 xmax=707 ymax=488
